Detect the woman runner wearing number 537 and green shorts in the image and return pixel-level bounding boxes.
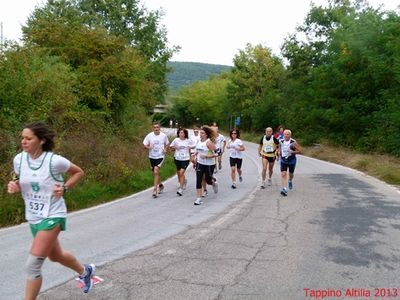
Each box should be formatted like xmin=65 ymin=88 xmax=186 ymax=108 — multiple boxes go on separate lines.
xmin=7 ymin=122 xmax=95 ymax=300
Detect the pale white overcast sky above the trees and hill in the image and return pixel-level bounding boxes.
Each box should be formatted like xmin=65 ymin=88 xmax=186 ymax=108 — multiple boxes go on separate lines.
xmin=0 ymin=0 xmax=400 ymax=65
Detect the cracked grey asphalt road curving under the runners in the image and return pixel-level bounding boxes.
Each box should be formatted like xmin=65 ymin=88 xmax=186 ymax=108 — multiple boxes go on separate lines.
xmin=0 ymin=137 xmax=400 ymax=299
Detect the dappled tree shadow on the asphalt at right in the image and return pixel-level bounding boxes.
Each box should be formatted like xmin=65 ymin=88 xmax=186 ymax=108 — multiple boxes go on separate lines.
xmin=311 ymin=174 xmax=400 ymax=270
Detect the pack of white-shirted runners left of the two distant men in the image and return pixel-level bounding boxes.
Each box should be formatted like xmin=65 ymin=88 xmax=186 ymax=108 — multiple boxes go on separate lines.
xmin=143 ymin=123 xmax=245 ymax=205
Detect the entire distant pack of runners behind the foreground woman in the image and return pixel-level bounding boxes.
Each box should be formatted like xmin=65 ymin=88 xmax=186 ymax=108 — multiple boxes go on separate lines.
xmin=143 ymin=123 xmax=300 ymax=205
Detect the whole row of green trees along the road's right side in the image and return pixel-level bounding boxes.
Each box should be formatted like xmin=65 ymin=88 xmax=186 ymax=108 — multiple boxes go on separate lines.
xmin=167 ymin=0 xmax=400 ymax=155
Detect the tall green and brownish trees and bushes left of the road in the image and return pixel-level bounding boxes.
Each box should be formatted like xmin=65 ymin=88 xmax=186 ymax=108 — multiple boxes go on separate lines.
xmin=0 ymin=0 xmax=175 ymax=226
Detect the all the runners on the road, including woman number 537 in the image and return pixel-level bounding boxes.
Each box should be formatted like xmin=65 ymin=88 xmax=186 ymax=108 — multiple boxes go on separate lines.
xmin=7 ymin=122 xmax=300 ymax=300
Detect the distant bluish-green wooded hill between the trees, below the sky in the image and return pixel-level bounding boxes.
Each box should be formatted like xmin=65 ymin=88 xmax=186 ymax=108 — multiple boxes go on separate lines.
xmin=167 ymin=61 xmax=232 ymax=91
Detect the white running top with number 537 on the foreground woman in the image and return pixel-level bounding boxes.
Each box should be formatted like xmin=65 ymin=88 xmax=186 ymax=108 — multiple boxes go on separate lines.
xmin=13 ymin=152 xmax=71 ymax=224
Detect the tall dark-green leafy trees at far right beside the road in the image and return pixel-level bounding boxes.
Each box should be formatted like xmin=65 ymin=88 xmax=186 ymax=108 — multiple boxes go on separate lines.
xmin=283 ymin=1 xmax=400 ymax=155
